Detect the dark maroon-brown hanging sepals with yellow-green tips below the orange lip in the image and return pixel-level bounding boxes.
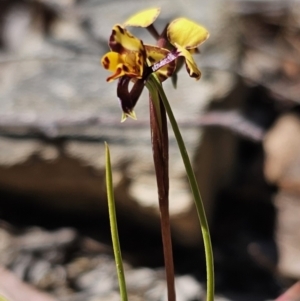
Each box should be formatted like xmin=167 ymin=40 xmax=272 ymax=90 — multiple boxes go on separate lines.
xmin=117 ymin=76 xmax=144 ymax=122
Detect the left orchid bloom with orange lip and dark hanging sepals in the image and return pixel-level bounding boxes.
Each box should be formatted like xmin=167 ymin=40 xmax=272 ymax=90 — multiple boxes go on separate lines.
xmin=101 ymin=25 xmax=176 ymax=121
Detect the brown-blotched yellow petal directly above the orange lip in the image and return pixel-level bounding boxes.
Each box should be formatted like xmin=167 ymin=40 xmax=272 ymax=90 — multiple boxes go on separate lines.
xmin=109 ymin=25 xmax=145 ymax=54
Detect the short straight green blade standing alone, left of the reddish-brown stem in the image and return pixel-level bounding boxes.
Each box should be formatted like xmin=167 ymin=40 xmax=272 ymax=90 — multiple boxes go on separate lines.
xmin=105 ymin=142 xmax=128 ymax=301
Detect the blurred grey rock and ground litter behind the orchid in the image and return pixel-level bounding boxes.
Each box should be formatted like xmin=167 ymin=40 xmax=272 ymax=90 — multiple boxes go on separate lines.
xmin=0 ymin=0 xmax=300 ymax=301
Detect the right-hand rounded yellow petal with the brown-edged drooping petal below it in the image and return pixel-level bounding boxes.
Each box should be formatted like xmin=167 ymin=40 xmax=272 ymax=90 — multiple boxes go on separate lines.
xmin=167 ymin=18 xmax=209 ymax=80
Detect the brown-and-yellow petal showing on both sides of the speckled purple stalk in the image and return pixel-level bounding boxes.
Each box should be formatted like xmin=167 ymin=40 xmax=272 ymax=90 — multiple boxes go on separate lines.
xmin=145 ymin=45 xmax=176 ymax=82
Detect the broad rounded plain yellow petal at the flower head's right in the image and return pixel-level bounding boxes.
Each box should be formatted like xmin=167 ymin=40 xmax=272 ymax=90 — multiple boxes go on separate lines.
xmin=167 ymin=18 xmax=209 ymax=49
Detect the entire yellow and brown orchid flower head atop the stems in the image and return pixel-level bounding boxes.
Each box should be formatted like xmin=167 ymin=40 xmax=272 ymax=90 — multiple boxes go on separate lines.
xmin=101 ymin=8 xmax=209 ymax=121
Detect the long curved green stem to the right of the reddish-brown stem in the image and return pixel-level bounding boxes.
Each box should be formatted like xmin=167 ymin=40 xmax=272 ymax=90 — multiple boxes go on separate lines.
xmin=148 ymin=74 xmax=215 ymax=301
